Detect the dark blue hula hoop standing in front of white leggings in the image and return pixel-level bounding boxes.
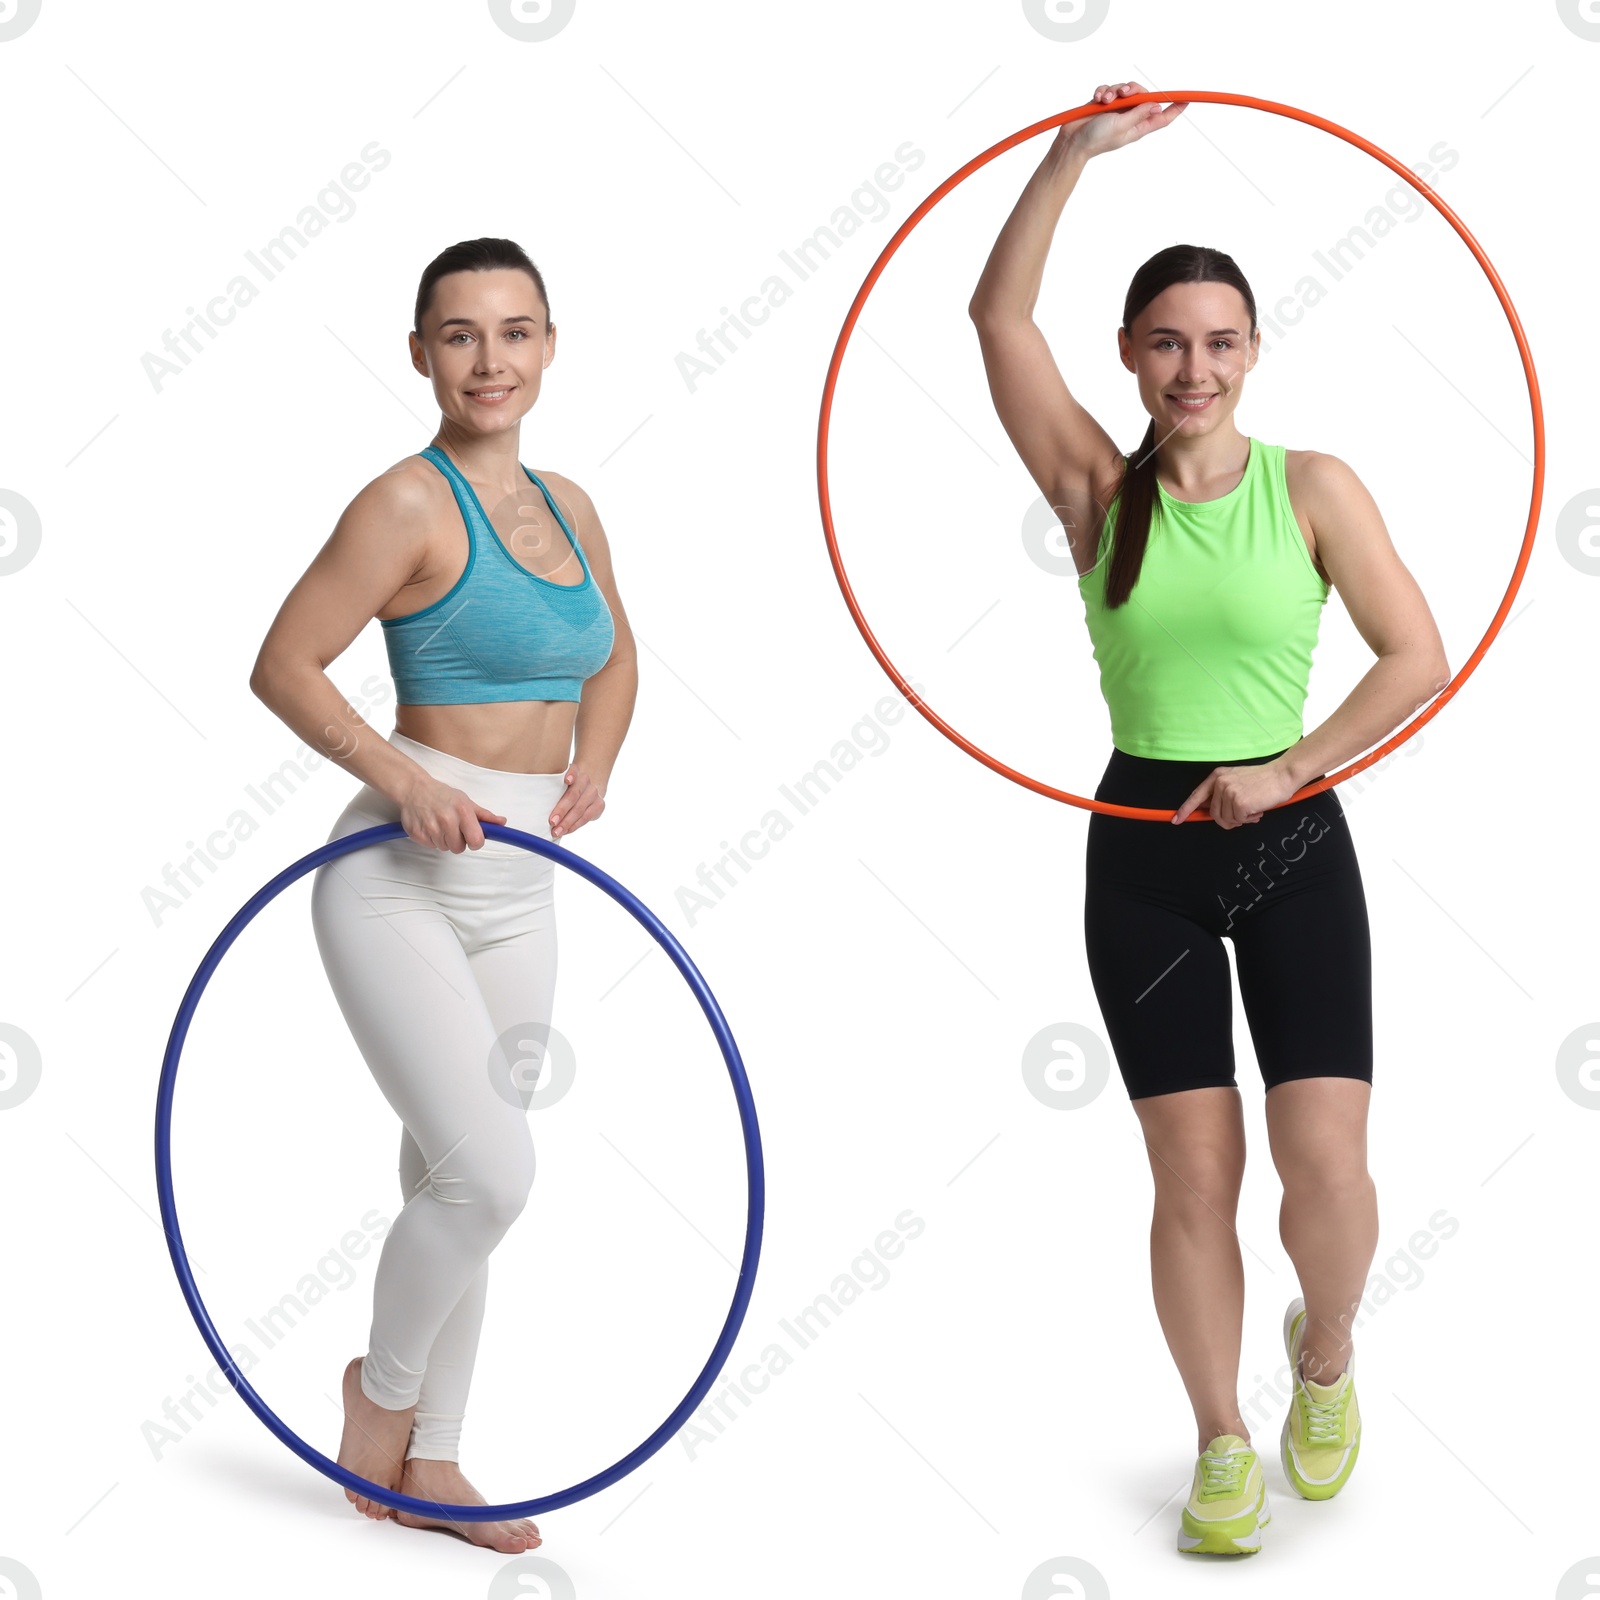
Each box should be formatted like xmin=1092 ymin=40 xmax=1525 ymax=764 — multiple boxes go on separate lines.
xmin=155 ymin=822 xmax=766 ymax=1522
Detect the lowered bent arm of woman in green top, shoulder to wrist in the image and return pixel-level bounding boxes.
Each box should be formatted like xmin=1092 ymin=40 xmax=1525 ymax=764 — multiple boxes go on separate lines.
xmin=1278 ymin=451 xmax=1451 ymax=792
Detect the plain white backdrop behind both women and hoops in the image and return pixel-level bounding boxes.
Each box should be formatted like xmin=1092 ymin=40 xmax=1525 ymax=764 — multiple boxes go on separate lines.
xmin=0 ymin=0 xmax=1600 ymax=1600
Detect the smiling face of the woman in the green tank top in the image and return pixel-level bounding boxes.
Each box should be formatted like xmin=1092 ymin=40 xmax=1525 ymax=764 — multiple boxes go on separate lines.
xmin=1117 ymin=283 xmax=1261 ymax=442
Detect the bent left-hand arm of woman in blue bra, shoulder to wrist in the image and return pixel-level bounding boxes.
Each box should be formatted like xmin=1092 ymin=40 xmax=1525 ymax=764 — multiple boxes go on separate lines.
xmin=250 ymin=467 xmax=444 ymax=803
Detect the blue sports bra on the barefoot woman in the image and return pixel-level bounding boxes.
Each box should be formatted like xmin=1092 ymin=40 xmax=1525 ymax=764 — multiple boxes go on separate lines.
xmin=382 ymin=445 xmax=616 ymax=706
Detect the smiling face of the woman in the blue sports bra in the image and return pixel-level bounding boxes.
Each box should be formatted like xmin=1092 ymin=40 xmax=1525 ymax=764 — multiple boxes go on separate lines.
xmin=410 ymin=267 xmax=555 ymax=434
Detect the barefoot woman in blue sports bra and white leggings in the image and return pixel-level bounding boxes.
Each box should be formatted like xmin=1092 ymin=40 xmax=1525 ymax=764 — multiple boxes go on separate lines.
xmin=250 ymin=238 xmax=638 ymax=1555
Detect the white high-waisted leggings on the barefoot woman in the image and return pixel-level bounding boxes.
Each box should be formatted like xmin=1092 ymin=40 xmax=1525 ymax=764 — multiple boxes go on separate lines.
xmin=312 ymin=733 xmax=565 ymax=1461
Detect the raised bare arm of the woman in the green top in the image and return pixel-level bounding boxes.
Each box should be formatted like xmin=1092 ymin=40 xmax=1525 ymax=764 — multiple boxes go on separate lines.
xmin=966 ymin=83 xmax=1184 ymax=573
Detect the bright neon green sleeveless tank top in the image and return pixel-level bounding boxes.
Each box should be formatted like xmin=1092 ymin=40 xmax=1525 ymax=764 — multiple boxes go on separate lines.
xmin=1078 ymin=438 xmax=1330 ymax=763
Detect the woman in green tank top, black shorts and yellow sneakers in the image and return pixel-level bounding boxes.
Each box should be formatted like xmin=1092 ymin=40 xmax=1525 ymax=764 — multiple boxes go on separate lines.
xmin=970 ymin=83 xmax=1450 ymax=1554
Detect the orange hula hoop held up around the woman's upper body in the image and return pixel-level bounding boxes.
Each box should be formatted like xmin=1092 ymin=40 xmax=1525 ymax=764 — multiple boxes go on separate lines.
xmin=816 ymin=90 xmax=1544 ymax=822
